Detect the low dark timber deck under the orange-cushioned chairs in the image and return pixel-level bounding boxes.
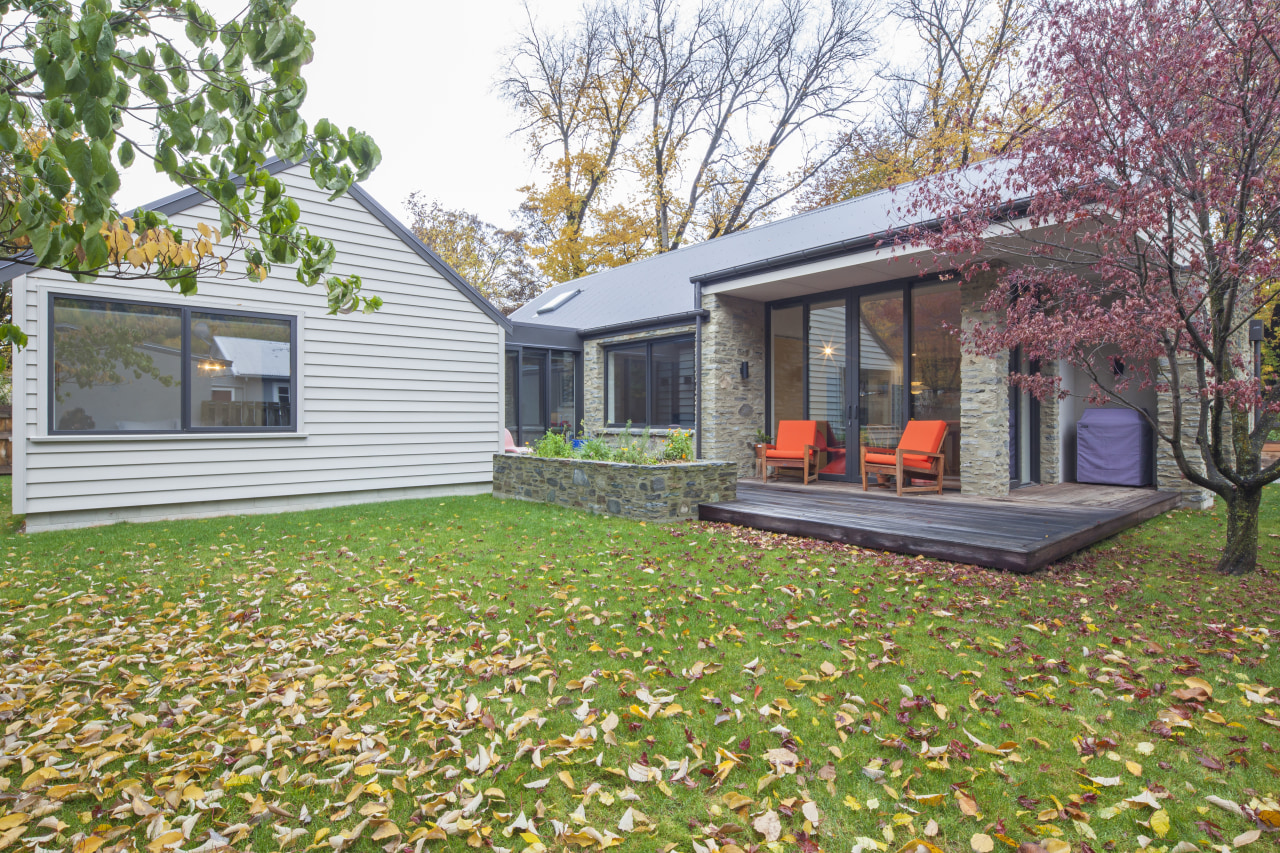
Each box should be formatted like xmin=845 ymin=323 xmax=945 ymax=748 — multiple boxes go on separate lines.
xmin=698 ymin=480 xmax=1179 ymax=573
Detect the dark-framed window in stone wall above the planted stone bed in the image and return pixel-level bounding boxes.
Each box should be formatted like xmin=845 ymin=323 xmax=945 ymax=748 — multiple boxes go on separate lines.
xmin=604 ymin=338 xmax=696 ymax=429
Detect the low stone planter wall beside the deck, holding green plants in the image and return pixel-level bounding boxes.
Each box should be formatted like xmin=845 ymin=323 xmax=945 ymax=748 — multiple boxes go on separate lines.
xmin=493 ymin=453 xmax=737 ymax=521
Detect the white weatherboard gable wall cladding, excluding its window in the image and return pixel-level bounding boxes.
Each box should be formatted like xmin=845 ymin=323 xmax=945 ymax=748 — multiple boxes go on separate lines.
xmin=14 ymin=167 xmax=503 ymax=530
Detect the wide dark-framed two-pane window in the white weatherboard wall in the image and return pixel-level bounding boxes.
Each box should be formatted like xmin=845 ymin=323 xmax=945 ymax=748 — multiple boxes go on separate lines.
xmin=49 ymin=295 xmax=297 ymax=434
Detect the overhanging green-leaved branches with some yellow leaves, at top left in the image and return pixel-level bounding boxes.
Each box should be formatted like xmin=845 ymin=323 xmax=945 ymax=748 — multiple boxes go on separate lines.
xmin=0 ymin=0 xmax=381 ymax=356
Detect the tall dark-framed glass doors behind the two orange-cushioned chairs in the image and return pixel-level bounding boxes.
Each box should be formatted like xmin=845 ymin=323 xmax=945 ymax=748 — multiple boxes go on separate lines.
xmin=767 ymin=279 xmax=960 ymax=480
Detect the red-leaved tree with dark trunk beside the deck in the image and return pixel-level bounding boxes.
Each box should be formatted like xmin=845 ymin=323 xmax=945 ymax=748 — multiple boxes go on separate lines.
xmin=909 ymin=0 xmax=1280 ymax=574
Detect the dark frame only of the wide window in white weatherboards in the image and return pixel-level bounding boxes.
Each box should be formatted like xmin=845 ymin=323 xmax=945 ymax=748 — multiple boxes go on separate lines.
xmin=45 ymin=291 xmax=301 ymax=437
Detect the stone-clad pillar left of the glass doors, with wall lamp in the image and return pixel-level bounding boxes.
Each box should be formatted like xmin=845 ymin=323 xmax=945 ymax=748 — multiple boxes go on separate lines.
xmin=699 ymin=295 xmax=765 ymax=476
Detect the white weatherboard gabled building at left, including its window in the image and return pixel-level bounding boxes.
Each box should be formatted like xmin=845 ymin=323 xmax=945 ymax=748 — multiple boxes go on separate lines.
xmin=10 ymin=161 xmax=509 ymax=532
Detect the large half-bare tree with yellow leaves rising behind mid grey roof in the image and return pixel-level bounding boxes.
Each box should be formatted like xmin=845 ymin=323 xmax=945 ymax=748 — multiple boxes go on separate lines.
xmin=502 ymin=0 xmax=877 ymax=280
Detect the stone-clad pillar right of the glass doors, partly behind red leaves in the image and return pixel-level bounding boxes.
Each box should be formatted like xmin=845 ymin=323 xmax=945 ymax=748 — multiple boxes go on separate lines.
xmin=960 ymin=270 xmax=1008 ymax=497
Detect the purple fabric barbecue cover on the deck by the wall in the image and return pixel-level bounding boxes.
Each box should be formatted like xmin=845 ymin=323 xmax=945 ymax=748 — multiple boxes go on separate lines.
xmin=1075 ymin=409 xmax=1152 ymax=485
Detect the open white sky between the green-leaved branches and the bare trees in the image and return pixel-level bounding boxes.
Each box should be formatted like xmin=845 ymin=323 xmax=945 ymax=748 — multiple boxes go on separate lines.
xmin=120 ymin=0 xmax=581 ymax=225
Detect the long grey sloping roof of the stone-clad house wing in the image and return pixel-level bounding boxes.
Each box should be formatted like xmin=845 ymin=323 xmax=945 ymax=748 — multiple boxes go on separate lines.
xmin=511 ymin=161 xmax=1018 ymax=332
